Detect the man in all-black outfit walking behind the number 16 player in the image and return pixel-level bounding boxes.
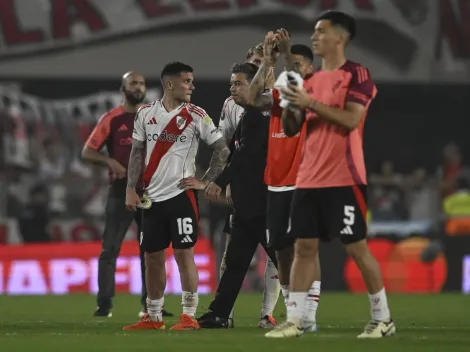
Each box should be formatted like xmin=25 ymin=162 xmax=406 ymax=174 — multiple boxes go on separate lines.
xmin=198 ymin=63 xmax=277 ymax=328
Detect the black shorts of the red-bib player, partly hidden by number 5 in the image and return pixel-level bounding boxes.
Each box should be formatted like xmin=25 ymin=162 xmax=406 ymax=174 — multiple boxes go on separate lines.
xmin=266 ymin=190 xmax=294 ymax=251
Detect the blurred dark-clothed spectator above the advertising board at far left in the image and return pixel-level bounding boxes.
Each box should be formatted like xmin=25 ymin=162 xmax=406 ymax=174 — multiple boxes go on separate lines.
xmin=18 ymin=185 xmax=50 ymax=243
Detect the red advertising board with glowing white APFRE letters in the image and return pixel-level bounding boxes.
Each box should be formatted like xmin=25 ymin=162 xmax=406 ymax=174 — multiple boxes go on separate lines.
xmin=0 ymin=239 xmax=217 ymax=295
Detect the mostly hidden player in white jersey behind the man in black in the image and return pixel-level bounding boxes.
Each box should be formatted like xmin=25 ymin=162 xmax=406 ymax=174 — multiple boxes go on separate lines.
xmin=219 ymin=43 xmax=281 ymax=328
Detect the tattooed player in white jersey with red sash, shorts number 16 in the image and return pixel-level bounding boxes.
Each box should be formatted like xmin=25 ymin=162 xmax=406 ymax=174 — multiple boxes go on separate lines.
xmin=124 ymin=62 xmax=230 ymax=330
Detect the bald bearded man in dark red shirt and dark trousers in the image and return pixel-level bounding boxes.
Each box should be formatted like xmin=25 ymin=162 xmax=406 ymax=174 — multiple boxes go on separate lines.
xmin=82 ymin=72 xmax=172 ymax=317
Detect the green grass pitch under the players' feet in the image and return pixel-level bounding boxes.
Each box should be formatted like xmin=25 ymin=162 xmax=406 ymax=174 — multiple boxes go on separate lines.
xmin=0 ymin=292 xmax=470 ymax=352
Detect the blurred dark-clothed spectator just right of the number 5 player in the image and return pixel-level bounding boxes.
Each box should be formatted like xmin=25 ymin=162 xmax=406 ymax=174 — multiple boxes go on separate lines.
xmin=369 ymin=160 xmax=406 ymax=221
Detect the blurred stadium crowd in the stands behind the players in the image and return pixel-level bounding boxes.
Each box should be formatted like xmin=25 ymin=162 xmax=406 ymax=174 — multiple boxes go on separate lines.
xmin=0 ymin=108 xmax=468 ymax=242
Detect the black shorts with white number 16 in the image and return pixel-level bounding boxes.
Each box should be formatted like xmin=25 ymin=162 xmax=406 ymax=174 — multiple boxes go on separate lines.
xmin=140 ymin=190 xmax=199 ymax=253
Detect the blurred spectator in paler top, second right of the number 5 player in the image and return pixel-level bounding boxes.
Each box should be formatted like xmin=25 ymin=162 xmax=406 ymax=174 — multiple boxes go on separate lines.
xmin=406 ymin=167 xmax=439 ymax=221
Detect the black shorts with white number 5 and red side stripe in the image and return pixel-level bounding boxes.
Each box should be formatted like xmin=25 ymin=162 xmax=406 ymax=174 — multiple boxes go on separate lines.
xmin=290 ymin=185 xmax=367 ymax=244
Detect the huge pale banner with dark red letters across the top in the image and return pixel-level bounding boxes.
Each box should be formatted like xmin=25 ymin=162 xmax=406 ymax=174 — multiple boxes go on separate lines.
xmin=0 ymin=0 xmax=470 ymax=82
